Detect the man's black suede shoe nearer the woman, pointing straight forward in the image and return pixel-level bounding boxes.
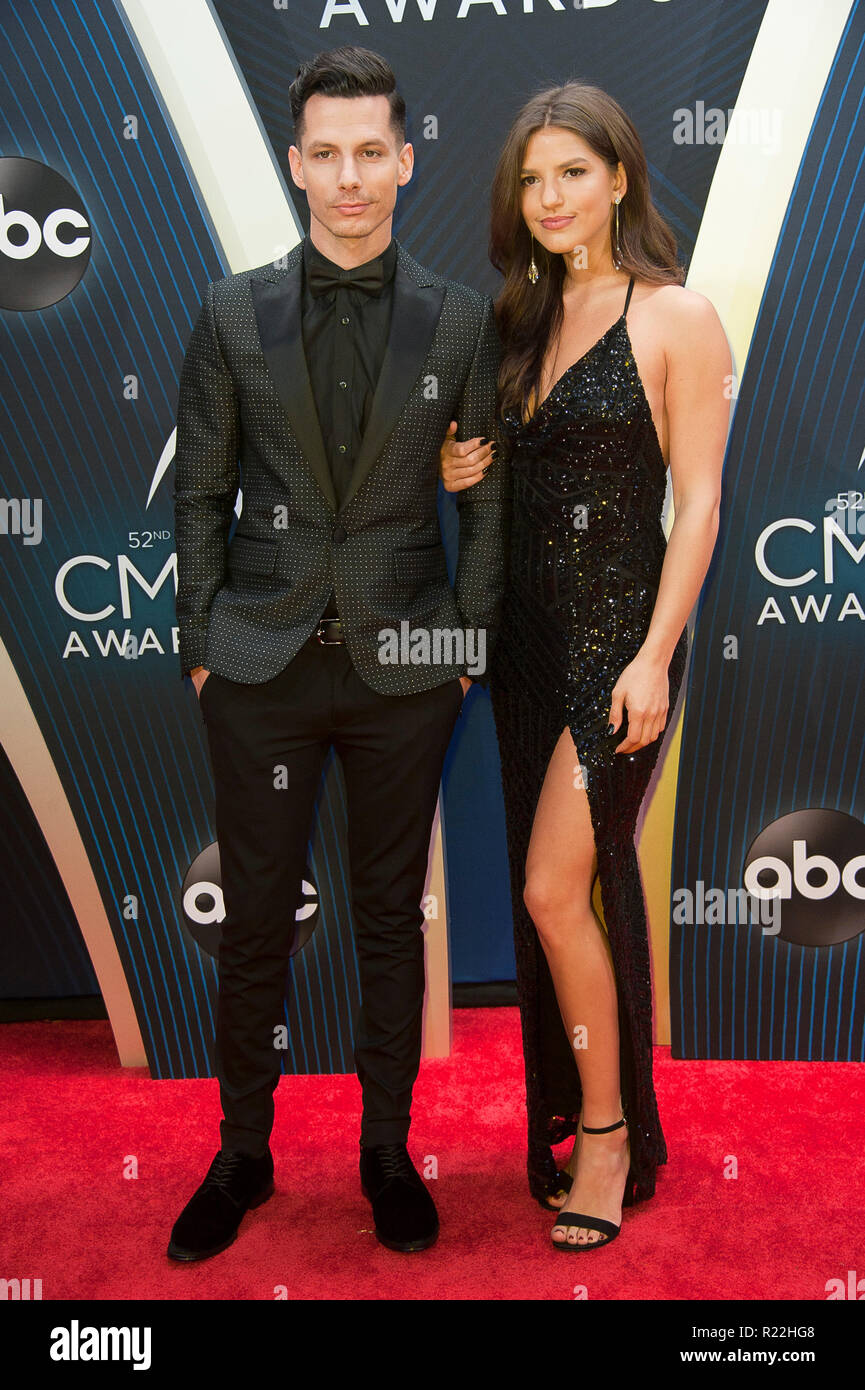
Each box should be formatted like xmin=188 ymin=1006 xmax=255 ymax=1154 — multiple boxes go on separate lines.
xmin=360 ymin=1144 xmax=438 ymax=1250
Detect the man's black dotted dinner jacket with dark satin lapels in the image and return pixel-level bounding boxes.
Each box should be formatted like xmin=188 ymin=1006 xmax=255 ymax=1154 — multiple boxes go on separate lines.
xmin=174 ymin=242 xmax=510 ymax=695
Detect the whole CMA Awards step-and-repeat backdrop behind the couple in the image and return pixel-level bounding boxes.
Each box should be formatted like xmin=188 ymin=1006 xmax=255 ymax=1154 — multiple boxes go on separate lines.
xmin=0 ymin=0 xmax=865 ymax=1077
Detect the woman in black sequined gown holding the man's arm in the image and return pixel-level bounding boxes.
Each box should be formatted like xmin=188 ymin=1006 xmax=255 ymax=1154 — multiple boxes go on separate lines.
xmin=442 ymin=82 xmax=731 ymax=1252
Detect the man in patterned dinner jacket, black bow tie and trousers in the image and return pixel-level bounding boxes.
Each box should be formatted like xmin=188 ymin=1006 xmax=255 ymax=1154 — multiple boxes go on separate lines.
xmin=168 ymin=47 xmax=509 ymax=1261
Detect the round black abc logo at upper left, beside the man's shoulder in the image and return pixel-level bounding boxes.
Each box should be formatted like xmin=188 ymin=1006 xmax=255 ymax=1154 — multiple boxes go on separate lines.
xmin=0 ymin=157 xmax=92 ymax=309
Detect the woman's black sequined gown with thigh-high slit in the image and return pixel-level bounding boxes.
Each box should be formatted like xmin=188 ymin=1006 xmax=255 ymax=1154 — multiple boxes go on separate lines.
xmin=490 ymin=277 xmax=687 ymax=1201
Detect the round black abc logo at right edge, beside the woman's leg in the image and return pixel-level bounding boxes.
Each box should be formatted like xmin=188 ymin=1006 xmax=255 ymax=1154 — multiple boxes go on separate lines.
xmin=743 ymin=809 xmax=865 ymax=947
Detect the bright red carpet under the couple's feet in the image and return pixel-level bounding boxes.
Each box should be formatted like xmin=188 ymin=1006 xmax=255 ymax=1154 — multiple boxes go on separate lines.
xmin=0 ymin=1009 xmax=865 ymax=1300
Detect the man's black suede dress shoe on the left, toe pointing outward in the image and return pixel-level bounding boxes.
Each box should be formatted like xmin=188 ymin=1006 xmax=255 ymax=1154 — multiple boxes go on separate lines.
xmin=167 ymin=1148 xmax=274 ymax=1261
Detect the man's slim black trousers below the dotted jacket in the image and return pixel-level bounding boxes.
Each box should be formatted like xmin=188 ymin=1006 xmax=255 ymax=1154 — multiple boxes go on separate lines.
xmin=200 ymin=637 xmax=463 ymax=1154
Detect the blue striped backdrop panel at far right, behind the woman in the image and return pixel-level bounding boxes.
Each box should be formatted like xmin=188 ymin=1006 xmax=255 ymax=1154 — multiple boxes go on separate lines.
xmin=670 ymin=6 xmax=865 ymax=1062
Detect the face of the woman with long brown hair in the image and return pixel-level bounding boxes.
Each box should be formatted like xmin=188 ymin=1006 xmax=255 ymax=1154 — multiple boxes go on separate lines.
xmin=520 ymin=125 xmax=626 ymax=264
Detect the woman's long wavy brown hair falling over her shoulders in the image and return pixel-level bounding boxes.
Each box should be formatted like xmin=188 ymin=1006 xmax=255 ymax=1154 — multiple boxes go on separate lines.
xmin=490 ymin=82 xmax=686 ymax=420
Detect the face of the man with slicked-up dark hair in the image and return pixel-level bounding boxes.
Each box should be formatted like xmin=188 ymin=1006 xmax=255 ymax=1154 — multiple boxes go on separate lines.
xmin=288 ymin=92 xmax=414 ymax=245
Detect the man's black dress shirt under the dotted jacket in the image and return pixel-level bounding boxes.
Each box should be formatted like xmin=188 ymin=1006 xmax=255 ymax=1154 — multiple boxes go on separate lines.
xmin=302 ymin=236 xmax=396 ymax=617
